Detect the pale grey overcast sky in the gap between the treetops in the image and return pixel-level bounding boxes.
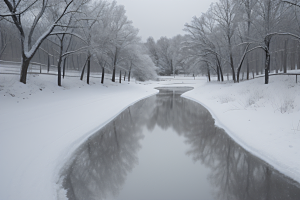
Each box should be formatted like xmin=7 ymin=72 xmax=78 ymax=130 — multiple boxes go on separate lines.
xmin=110 ymin=0 xmax=216 ymax=41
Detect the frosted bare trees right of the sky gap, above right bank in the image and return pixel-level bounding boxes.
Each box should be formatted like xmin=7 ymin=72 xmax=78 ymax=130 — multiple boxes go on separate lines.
xmin=146 ymin=0 xmax=300 ymax=84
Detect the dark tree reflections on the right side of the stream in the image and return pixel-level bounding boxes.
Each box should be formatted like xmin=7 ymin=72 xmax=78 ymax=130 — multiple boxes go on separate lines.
xmin=150 ymin=88 xmax=300 ymax=200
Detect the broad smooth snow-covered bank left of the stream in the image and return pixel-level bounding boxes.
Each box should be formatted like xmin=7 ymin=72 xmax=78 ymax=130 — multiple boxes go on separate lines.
xmin=0 ymin=75 xmax=157 ymax=200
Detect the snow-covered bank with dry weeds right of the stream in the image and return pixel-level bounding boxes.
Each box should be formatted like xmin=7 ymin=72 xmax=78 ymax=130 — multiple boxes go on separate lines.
xmin=182 ymin=76 xmax=300 ymax=183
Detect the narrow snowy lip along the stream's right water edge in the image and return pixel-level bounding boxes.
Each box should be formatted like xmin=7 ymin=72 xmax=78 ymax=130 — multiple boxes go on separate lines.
xmin=182 ymin=93 xmax=300 ymax=186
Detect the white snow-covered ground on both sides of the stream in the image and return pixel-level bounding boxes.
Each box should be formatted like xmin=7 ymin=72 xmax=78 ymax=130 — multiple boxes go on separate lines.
xmin=0 ymin=71 xmax=300 ymax=200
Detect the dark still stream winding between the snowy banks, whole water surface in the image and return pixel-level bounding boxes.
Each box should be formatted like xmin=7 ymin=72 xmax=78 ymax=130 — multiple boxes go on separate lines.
xmin=61 ymin=88 xmax=300 ymax=200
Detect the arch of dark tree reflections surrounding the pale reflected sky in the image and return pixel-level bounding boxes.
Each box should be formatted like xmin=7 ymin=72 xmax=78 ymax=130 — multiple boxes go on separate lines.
xmin=62 ymin=90 xmax=300 ymax=200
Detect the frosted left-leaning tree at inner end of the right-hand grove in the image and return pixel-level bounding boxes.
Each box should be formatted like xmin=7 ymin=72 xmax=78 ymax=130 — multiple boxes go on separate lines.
xmin=184 ymin=11 xmax=228 ymax=81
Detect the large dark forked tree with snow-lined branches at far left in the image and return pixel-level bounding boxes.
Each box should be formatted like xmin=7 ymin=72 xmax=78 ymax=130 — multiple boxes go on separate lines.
xmin=0 ymin=0 xmax=89 ymax=84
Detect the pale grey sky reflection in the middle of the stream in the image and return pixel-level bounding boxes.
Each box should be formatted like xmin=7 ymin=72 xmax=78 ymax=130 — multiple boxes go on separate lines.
xmin=115 ymin=127 xmax=212 ymax=200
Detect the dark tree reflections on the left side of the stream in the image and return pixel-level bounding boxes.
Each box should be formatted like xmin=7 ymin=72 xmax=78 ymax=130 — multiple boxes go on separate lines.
xmin=61 ymin=97 xmax=153 ymax=200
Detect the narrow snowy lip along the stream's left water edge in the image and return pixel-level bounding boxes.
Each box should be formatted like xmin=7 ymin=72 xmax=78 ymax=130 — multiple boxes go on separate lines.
xmin=53 ymin=91 xmax=159 ymax=200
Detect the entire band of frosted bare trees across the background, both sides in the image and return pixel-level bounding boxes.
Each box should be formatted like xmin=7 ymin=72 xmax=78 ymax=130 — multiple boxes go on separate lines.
xmin=0 ymin=0 xmax=300 ymax=86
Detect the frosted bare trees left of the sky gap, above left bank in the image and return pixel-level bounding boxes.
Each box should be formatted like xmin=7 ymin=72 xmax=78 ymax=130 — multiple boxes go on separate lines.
xmin=0 ymin=0 xmax=156 ymax=86
